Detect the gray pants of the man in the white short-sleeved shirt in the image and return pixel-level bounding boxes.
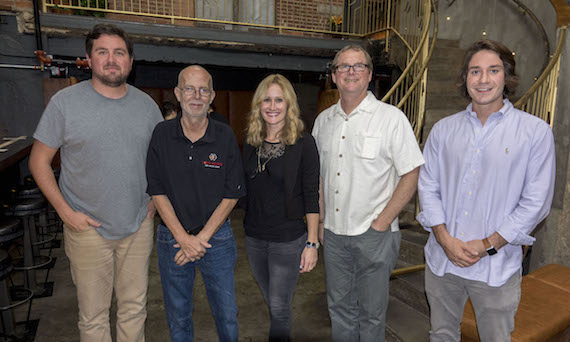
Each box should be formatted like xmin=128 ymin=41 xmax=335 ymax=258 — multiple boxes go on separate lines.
xmin=324 ymin=228 xmax=401 ymax=342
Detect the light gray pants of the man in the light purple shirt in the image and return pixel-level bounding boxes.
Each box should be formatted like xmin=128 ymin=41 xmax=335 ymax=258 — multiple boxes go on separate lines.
xmin=425 ymin=264 xmax=521 ymax=342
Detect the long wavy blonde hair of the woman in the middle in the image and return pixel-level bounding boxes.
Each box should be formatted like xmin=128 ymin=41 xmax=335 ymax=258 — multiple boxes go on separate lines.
xmin=246 ymin=74 xmax=305 ymax=147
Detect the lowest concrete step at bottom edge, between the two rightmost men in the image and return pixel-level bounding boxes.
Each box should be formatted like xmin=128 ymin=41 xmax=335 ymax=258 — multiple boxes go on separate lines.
xmin=386 ymin=297 xmax=429 ymax=342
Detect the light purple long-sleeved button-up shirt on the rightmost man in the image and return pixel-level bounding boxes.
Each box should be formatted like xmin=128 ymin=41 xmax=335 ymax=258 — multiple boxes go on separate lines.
xmin=417 ymin=99 xmax=556 ymax=287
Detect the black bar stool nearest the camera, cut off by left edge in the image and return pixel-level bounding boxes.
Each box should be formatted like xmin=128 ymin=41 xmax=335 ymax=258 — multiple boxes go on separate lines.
xmin=0 ymin=217 xmax=33 ymax=340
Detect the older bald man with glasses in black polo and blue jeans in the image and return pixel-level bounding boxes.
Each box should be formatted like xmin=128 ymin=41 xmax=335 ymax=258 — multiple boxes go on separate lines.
xmin=147 ymin=65 xmax=245 ymax=342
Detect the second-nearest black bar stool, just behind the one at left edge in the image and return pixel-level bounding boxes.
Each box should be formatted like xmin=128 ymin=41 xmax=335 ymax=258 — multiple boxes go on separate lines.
xmin=4 ymin=197 xmax=53 ymax=298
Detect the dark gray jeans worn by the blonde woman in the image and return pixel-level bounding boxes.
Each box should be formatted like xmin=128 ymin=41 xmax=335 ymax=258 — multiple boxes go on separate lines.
xmin=245 ymin=233 xmax=307 ymax=341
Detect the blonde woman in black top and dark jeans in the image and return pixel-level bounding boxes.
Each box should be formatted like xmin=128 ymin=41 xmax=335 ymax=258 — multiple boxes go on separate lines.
xmin=243 ymin=74 xmax=319 ymax=341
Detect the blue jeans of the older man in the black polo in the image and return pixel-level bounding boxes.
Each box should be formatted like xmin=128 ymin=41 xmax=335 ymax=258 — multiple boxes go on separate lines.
xmin=156 ymin=222 xmax=238 ymax=342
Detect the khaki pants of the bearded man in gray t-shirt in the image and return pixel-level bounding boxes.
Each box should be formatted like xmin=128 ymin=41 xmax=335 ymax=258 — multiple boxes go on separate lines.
xmin=64 ymin=217 xmax=154 ymax=342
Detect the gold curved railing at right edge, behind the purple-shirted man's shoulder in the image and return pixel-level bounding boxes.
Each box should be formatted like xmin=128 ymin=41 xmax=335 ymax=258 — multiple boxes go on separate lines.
xmin=515 ymin=26 xmax=566 ymax=127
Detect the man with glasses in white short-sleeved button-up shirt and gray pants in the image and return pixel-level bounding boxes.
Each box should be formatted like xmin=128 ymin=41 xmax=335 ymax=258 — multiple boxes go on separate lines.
xmin=313 ymin=45 xmax=424 ymax=342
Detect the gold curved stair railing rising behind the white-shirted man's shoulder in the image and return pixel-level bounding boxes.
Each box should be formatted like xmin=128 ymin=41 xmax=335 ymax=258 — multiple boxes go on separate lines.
xmin=382 ymin=0 xmax=437 ymax=142
